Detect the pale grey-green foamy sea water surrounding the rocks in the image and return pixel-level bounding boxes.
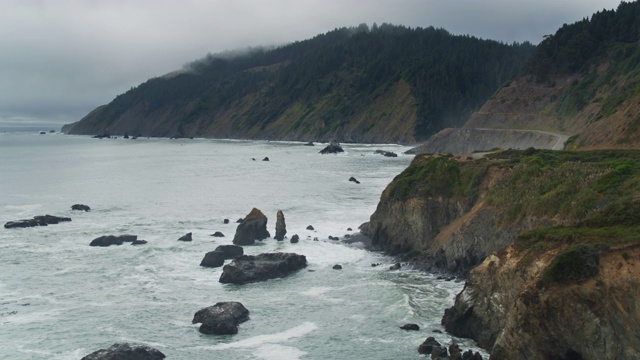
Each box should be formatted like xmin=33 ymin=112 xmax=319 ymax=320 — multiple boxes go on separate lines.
xmin=0 ymin=132 xmax=478 ymax=359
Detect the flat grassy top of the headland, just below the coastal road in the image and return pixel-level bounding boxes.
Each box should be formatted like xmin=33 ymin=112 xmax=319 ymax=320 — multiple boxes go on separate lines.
xmin=487 ymin=149 xmax=640 ymax=223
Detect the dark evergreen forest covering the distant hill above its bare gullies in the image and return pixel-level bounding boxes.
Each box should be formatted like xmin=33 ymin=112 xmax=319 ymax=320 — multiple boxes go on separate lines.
xmin=103 ymin=24 xmax=535 ymax=139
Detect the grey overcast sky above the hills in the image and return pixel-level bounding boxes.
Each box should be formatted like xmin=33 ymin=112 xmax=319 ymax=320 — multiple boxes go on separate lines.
xmin=0 ymin=0 xmax=619 ymax=124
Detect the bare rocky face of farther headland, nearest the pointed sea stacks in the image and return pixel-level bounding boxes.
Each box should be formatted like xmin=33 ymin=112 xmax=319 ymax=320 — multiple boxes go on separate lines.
xmin=368 ymin=155 xmax=562 ymax=275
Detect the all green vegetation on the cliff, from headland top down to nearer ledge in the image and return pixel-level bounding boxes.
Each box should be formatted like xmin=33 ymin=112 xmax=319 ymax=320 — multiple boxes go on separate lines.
xmin=480 ymin=149 xmax=640 ymax=286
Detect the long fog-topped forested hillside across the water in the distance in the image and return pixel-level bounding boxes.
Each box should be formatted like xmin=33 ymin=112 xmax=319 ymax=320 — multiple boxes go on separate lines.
xmin=67 ymin=24 xmax=535 ymax=143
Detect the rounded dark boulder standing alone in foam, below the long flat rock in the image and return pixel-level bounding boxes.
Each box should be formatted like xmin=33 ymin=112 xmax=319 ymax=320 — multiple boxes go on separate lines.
xmin=191 ymin=301 xmax=249 ymax=335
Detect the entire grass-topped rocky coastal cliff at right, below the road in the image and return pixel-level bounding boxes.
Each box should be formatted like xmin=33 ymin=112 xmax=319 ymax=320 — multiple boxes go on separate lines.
xmin=369 ymin=149 xmax=640 ymax=360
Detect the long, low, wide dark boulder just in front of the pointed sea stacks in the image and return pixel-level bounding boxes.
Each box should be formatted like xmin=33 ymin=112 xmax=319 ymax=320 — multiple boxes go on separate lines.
xmin=220 ymin=253 xmax=307 ymax=284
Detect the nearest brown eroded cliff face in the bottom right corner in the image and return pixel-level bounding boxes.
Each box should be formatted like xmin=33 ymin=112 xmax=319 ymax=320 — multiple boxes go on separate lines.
xmin=443 ymin=244 xmax=640 ymax=360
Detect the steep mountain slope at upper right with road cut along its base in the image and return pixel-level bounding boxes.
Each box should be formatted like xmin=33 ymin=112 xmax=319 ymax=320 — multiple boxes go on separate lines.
xmin=422 ymin=2 xmax=640 ymax=152
